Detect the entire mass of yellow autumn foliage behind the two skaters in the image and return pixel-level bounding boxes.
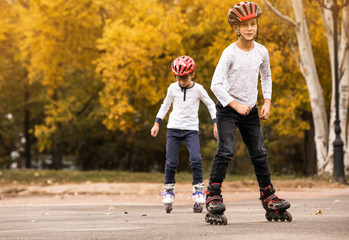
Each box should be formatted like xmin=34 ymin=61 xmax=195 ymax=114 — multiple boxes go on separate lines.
xmin=0 ymin=0 xmax=331 ymax=150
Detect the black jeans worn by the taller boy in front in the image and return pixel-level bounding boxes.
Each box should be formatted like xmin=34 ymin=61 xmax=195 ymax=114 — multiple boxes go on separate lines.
xmin=210 ymin=102 xmax=271 ymax=187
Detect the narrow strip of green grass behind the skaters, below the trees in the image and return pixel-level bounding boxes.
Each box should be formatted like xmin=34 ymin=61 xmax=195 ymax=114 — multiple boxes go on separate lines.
xmin=0 ymin=170 xmax=323 ymax=185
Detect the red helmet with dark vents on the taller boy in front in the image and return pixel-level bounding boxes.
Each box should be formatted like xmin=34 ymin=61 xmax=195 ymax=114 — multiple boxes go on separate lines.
xmin=228 ymin=2 xmax=262 ymax=26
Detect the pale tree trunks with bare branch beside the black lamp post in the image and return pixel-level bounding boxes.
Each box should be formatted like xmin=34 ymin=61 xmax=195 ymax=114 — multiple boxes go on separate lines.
xmin=265 ymin=0 xmax=349 ymax=175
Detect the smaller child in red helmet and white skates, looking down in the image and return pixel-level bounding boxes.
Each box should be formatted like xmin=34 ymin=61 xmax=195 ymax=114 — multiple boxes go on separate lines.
xmin=151 ymin=56 xmax=217 ymax=213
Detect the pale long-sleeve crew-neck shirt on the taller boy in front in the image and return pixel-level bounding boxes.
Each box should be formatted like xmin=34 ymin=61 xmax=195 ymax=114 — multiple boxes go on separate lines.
xmin=211 ymin=42 xmax=272 ymax=107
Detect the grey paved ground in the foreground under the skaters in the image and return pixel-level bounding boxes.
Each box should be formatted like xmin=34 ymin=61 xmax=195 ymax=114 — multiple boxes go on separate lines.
xmin=0 ymin=188 xmax=349 ymax=240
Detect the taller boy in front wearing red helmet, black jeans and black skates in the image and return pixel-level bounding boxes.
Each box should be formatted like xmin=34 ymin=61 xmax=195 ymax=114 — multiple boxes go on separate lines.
xmin=205 ymin=2 xmax=292 ymax=224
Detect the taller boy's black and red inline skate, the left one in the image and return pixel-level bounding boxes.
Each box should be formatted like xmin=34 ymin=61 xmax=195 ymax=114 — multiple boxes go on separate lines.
xmin=205 ymin=183 xmax=228 ymax=225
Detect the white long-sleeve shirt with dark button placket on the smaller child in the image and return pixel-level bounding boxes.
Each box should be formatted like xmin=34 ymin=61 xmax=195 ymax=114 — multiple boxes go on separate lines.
xmin=156 ymin=82 xmax=216 ymax=131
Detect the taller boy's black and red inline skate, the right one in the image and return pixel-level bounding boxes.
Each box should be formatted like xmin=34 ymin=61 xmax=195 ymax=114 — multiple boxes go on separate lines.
xmin=259 ymin=185 xmax=292 ymax=222
